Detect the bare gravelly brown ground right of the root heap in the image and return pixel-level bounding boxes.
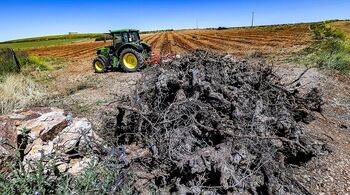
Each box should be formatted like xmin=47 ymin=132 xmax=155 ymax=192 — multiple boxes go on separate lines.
xmin=279 ymin=65 xmax=350 ymax=194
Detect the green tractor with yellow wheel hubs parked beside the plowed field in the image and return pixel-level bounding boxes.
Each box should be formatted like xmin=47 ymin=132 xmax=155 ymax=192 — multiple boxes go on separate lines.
xmin=93 ymin=29 xmax=151 ymax=73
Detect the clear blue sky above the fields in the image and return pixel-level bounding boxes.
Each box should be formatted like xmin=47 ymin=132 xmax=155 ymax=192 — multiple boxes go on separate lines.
xmin=0 ymin=0 xmax=350 ymax=41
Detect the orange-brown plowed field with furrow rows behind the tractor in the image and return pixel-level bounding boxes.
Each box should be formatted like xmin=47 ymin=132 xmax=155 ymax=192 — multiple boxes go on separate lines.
xmin=28 ymin=24 xmax=311 ymax=60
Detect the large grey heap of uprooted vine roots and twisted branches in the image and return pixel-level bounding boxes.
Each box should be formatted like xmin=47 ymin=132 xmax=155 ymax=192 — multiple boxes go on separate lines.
xmin=106 ymin=51 xmax=322 ymax=194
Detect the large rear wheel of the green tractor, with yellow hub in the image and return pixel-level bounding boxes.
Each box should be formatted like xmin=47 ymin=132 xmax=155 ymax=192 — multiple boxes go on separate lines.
xmin=119 ymin=48 xmax=144 ymax=72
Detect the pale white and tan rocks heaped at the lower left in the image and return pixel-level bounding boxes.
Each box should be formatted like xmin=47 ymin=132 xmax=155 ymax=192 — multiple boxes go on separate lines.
xmin=0 ymin=107 xmax=101 ymax=174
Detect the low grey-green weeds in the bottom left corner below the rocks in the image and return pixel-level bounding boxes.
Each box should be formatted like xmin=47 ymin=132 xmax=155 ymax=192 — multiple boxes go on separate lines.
xmin=0 ymin=157 xmax=133 ymax=195
